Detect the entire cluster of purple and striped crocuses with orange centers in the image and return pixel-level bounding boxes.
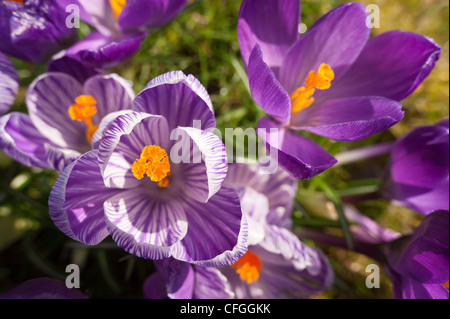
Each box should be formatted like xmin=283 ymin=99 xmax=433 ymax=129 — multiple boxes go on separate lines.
xmin=0 ymin=0 xmax=449 ymax=299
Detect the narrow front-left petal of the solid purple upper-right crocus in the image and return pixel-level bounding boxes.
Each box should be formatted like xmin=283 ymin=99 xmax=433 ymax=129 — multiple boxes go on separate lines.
xmin=247 ymin=45 xmax=291 ymax=124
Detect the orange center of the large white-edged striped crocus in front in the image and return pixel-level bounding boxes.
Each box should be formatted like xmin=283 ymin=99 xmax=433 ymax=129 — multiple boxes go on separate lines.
xmin=131 ymin=145 xmax=170 ymax=188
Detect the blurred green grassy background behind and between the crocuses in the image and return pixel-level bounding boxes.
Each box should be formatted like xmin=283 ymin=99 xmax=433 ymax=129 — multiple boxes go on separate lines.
xmin=0 ymin=0 xmax=449 ymax=299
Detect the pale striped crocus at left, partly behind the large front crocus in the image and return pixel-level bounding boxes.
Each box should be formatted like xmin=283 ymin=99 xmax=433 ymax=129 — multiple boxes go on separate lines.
xmin=0 ymin=72 xmax=134 ymax=171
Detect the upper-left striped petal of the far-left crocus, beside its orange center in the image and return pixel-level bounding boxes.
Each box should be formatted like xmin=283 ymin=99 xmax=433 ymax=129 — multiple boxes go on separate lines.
xmin=26 ymin=73 xmax=90 ymax=151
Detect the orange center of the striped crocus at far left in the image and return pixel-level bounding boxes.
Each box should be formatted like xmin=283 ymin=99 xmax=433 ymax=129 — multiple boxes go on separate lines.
xmin=69 ymin=95 xmax=98 ymax=143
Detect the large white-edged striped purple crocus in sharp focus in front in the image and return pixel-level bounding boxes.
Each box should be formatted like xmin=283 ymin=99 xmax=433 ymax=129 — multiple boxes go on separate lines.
xmin=49 ymin=72 xmax=247 ymax=266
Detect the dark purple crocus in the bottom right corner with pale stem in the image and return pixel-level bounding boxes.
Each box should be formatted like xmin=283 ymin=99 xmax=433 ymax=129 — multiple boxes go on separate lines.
xmin=299 ymin=206 xmax=449 ymax=299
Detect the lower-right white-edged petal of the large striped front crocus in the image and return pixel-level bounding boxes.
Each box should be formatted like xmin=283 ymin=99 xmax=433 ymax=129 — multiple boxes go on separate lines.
xmin=172 ymin=187 xmax=247 ymax=267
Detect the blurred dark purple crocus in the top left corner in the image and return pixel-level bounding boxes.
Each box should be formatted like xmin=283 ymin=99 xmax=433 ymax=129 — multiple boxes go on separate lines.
xmin=0 ymin=0 xmax=77 ymax=63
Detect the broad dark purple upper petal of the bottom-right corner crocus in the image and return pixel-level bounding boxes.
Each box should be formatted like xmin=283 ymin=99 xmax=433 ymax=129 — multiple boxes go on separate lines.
xmin=386 ymin=211 xmax=449 ymax=284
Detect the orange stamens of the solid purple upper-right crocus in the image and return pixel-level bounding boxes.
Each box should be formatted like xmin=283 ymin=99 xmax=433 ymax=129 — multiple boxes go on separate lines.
xmin=291 ymin=63 xmax=334 ymax=114
